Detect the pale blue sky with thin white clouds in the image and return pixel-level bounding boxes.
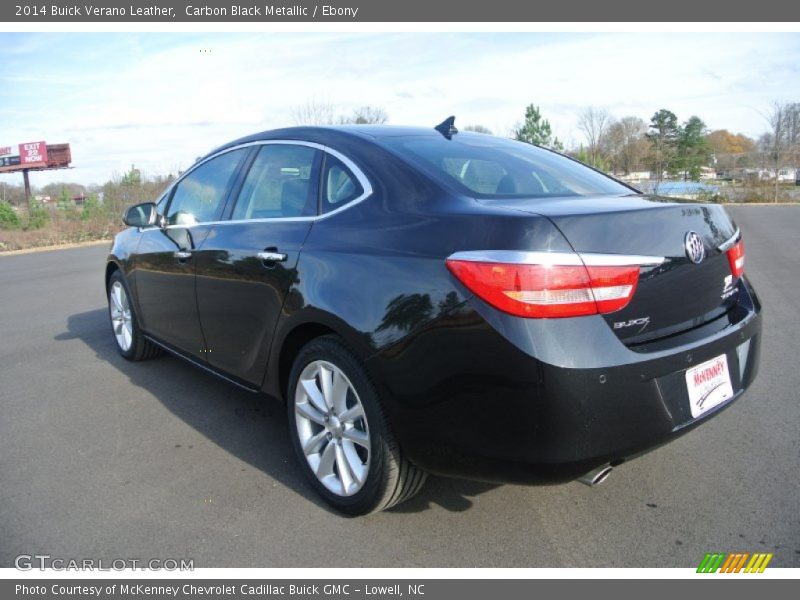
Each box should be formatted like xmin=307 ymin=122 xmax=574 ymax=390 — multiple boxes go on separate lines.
xmin=0 ymin=32 xmax=800 ymax=185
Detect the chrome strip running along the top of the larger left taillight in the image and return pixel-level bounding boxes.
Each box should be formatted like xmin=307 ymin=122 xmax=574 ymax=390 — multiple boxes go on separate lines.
xmin=447 ymin=250 xmax=667 ymax=267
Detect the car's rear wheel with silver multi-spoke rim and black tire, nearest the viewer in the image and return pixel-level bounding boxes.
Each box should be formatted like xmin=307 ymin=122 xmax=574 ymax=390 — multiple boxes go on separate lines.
xmin=287 ymin=336 xmax=426 ymax=515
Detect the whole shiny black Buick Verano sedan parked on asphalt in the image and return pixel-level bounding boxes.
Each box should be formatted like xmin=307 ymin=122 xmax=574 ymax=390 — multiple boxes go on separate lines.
xmin=105 ymin=119 xmax=761 ymax=514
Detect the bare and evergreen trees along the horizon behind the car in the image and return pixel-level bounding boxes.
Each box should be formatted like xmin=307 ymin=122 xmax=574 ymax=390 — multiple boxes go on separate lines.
xmin=0 ymin=98 xmax=800 ymax=229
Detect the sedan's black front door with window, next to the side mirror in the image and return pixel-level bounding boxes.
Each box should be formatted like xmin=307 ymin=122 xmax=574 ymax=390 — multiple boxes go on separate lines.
xmin=134 ymin=149 xmax=248 ymax=358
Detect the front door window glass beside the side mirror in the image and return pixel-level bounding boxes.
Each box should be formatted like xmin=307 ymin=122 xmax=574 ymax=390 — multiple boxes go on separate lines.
xmin=166 ymin=148 xmax=247 ymax=225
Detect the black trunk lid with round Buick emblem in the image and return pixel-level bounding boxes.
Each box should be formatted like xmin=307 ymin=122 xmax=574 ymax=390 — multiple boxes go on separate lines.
xmin=483 ymin=195 xmax=737 ymax=345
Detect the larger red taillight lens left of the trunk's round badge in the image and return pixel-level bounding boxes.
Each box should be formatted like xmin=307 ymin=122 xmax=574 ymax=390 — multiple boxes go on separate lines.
xmin=447 ymin=259 xmax=639 ymax=318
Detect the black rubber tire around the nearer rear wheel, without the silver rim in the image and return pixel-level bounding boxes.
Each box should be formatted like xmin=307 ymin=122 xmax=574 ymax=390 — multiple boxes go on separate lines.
xmin=286 ymin=335 xmax=427 ymax=515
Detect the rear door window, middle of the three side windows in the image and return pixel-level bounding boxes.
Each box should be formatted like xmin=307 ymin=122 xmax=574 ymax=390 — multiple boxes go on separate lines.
xmin=231 ymin=144 xmax=321 ymax=221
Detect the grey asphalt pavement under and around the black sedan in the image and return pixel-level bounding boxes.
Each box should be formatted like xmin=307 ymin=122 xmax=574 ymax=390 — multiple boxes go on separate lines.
xmin=0 ymin=206 xmax=800 ymax=567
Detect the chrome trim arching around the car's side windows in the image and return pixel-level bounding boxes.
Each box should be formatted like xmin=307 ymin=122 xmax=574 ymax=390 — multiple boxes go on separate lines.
xmin=163 ymin=140 xmax=373 ymax=229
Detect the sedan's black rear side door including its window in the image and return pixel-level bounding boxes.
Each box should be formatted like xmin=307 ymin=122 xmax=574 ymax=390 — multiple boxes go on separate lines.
xmin=196 ymin=142 xmax=322 ymax=385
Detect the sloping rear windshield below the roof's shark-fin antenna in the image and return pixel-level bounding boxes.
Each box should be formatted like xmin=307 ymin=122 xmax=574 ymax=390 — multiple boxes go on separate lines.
xmin=382 ymin=133 xmax=635 ymax=198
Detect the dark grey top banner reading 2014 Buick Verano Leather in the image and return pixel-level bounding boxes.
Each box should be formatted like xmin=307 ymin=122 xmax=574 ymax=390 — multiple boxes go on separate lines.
xmin=0 ymin=0 xmax=800 ymax=23
